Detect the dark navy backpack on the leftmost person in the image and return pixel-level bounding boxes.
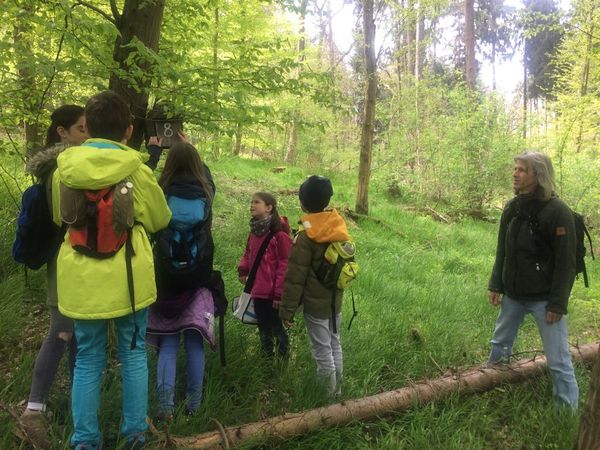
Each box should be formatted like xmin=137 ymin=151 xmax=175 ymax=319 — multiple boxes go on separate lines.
xmin=12 ymin=175 xmax=62 ymax=270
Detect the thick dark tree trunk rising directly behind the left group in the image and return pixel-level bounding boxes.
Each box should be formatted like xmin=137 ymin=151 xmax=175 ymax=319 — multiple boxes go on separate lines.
xmin=109 ymin=0 xmax=166 ymax=149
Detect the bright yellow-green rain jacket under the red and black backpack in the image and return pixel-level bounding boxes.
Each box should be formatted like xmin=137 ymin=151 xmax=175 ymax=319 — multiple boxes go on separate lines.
xmin=52 ymin=139 xmax=171 ymax=320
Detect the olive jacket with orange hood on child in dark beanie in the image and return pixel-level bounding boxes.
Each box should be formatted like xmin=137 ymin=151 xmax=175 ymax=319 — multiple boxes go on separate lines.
xmin=279 ymin=210 xmax=350 ymax=320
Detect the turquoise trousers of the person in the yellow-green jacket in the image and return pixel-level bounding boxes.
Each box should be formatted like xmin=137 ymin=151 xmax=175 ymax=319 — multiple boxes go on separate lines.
xmin=71 ymin=308 xmax=148 ymax=446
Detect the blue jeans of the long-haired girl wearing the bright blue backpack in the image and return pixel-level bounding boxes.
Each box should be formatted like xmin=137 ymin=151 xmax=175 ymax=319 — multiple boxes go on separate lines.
xmin=156 ymin=330 xmax=204 ymax=416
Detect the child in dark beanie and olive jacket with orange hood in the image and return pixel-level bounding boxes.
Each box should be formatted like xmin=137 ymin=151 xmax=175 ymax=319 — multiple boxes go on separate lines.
xmin=279 ymin=175 xmax=350 ymax=395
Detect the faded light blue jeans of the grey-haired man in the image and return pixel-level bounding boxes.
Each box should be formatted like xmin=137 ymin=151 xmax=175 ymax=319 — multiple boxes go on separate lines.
xmin=488 ymin=295 xmax=579 ymax=409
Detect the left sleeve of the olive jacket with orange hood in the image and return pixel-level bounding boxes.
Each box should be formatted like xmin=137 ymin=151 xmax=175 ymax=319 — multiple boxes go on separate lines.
xmin=279 ymin=232 xmax=312 ymax=320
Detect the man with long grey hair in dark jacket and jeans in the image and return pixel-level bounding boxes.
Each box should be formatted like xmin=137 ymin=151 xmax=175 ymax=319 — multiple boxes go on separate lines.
xmin=488 ymin=152 xmax=579 ymax=409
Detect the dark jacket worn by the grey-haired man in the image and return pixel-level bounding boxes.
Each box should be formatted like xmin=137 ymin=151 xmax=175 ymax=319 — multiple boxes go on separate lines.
xmin=488 ymin=195 xmax=576 ymax=314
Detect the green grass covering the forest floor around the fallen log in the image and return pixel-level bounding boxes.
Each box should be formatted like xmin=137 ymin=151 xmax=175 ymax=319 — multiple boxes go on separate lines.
xmin=0 ymin=158 xmax=600 ymax=449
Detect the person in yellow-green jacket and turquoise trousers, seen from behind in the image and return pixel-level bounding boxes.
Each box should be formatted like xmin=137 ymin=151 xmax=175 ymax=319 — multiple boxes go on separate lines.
xmin=52 ymin=91 xmax=171 ymax=449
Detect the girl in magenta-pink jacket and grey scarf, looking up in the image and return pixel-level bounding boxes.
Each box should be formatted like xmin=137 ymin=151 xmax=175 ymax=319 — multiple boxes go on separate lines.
xmin=238 ymin=192 xmax=292 ymax=359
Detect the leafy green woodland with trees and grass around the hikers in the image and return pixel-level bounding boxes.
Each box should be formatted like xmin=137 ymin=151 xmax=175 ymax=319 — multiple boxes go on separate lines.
xmin=0 ymin=0 xmax=600 ymax=448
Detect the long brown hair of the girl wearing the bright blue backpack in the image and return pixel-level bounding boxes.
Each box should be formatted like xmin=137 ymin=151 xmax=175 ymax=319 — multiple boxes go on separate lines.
xmin=158 ymin=142 xmax=213 ymax=203
